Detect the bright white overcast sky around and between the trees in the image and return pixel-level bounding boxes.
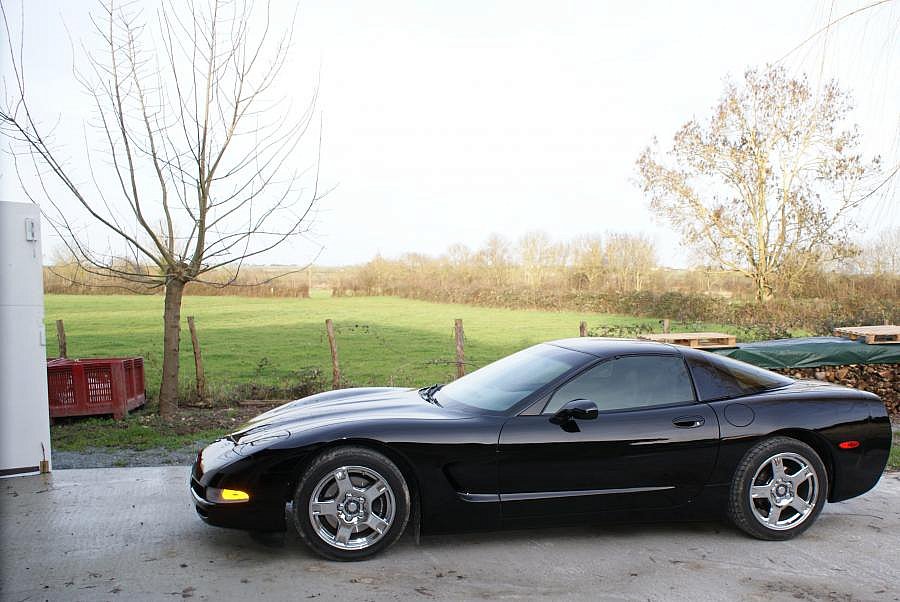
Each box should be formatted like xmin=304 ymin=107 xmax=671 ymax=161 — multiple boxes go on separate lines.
xmin=0 ymin=0 xmax=900 ymax=265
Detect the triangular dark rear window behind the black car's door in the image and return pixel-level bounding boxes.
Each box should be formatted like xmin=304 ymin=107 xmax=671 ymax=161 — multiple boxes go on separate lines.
xmin=685 ymin=351 xmax=794 ymax=401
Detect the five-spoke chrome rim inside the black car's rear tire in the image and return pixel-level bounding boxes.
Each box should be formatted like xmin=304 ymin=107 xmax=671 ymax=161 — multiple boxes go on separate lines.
xmin=750 ymin=452 xmax=819 ymax=531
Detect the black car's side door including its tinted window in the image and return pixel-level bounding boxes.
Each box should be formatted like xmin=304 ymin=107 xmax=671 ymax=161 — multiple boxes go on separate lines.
xmin=499 ymin=354 xmax=719 ymax=518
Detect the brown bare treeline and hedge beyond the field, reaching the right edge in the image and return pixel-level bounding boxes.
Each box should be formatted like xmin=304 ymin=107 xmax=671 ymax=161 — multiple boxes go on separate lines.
xmin=333 ymin=233 xmax=900 ymax=337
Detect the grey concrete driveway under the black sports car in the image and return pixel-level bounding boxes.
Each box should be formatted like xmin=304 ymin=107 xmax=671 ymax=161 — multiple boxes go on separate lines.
xmin=0 ymin=466 xmax=900 ymax=601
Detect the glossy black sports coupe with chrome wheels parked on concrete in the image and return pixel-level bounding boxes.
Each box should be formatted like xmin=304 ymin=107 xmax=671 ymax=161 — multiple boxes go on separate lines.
xmin=190 ymin=338 xmax=891 ymax=560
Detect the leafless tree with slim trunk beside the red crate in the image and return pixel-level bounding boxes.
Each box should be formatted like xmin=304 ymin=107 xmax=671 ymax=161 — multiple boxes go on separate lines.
xmin=0 ymin=0 xmax=321 ymax=417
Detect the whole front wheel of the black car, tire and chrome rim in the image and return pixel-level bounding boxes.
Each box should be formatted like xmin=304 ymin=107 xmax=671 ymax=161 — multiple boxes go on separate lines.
xmin=292 ymin=447 xmax=410 ymax=561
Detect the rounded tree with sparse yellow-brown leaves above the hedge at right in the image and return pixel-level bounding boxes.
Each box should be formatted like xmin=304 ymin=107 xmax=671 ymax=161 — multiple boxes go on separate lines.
xmin=637 ymin=67 xmax=879 ymax=300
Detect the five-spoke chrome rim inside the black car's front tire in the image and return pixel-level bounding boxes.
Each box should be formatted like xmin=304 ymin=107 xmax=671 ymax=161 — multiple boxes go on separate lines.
xmin=309 ymin=466 xmax=397 ymax=550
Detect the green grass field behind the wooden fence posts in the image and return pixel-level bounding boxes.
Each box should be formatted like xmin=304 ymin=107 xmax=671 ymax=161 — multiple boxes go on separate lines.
xmin=45 ymin=294 xmax=740 ymax=399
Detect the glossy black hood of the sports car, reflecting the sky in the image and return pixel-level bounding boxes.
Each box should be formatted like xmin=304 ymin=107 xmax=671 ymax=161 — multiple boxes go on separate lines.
xmin=231 ymin=387 xmax=468 ymax=443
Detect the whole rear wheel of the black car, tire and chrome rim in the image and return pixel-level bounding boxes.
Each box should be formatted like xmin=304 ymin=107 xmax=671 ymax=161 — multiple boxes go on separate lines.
xmin=728 ymin=437 xmax=828 ymax=541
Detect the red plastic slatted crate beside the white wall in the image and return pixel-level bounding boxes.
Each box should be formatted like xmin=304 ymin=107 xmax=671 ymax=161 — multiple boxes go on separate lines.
xmin=47 ymin=357 xmax=146 ymax=420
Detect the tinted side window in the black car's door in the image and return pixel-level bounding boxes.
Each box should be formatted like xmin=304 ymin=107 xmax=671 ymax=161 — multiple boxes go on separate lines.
xmin=544 ymin=355 xmax=695 ymax=414
